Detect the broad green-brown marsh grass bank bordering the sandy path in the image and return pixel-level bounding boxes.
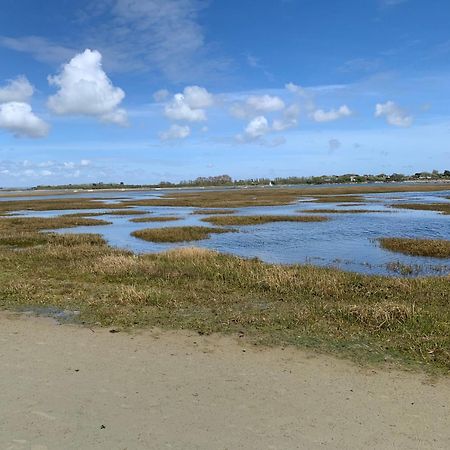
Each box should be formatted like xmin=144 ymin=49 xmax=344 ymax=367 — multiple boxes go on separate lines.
xmin=0 ymin=219 xmax=450 ymax=371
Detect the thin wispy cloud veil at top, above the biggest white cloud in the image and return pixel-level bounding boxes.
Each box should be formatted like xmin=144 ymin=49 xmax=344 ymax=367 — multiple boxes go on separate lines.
xmin=0 ymin=0 xmax=229 ymax=83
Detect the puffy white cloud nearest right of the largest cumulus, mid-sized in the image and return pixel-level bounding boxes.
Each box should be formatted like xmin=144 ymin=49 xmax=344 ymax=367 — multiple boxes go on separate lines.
xmin=164 ymin=86 xmax=214 ymax=122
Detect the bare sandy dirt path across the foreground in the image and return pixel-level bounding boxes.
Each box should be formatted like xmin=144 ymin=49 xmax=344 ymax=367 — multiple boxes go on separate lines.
xmin=0 ymin=313 xmax=450 ymax=450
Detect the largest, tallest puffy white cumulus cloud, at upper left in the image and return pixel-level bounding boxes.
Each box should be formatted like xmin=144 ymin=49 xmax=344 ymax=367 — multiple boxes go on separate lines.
xmin=48 ymin=49 xmax=127 ymax=125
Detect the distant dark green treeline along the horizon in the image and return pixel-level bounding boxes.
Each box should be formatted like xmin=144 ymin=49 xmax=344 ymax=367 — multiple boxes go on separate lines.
xmin=33 ymin=170 xmax=450 ymax=190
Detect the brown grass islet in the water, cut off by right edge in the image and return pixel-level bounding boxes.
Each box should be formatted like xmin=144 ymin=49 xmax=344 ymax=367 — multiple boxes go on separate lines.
xmin=379 ymin=238 xmax=450 ymax=258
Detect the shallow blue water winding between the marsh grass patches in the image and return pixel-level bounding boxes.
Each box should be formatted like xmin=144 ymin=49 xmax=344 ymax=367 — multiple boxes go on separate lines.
xmin=5 ymin=185 xmax=450 ymax=276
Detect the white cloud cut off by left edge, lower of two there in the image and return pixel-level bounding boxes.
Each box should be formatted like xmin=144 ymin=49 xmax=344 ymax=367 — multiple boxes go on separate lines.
xmin=0 ymin=102 xmax=49 ymax=138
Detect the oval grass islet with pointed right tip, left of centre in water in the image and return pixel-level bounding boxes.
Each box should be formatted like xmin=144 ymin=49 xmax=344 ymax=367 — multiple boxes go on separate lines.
xmin=131 ymin=227 xmax=234 ymax=242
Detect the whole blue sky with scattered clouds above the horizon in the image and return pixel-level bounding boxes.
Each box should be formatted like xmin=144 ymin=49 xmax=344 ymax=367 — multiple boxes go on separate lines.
xmin=0 ymin=0 xmax=450 ymax=187
